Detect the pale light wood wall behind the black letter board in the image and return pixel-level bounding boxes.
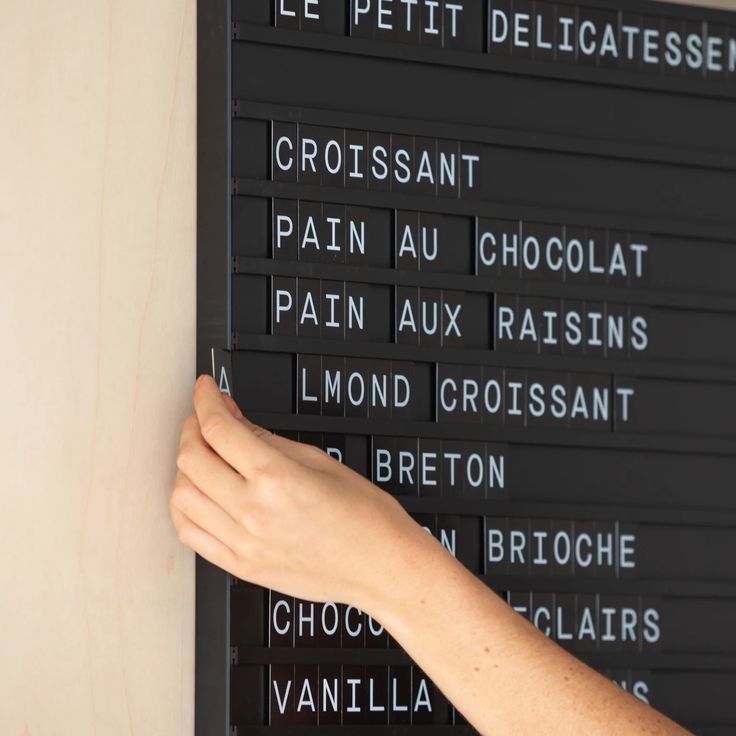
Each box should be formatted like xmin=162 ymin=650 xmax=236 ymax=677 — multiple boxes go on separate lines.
xmin=0 ymin=0 xmax=736 ymax=736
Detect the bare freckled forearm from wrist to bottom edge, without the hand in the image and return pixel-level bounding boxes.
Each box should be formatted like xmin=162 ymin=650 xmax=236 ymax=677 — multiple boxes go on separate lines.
xmin=372 ymin=539 xmax=686 ymax=736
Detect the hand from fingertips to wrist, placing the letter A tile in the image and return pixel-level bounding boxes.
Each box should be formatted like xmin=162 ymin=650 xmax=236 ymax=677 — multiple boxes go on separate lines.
xmin=170 ymin=376 xmax=438 ymax=616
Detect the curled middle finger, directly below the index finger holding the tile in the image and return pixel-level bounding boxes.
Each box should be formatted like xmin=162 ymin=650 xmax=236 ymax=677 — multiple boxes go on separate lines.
xmin=176 ymin=416 xmax=247 ymax=521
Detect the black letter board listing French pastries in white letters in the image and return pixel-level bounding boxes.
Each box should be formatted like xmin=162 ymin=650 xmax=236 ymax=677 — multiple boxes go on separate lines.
xmin=196 ymin=0 xmax=736 ymax=736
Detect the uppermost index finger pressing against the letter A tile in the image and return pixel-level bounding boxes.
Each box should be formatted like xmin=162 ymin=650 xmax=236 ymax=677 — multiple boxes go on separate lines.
xmin=194 ymin=376 xmax=285 ymax=478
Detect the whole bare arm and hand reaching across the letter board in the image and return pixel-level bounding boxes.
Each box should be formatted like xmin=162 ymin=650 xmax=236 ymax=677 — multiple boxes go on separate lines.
xmin=170 ymin=378 xmax=685 ymax=736
